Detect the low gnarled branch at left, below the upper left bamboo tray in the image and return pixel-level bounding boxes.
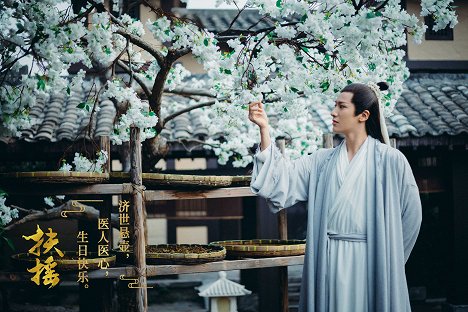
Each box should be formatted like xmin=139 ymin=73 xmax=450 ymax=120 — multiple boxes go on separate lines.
xmin=5 ymin=200 xmax=119 ymax=231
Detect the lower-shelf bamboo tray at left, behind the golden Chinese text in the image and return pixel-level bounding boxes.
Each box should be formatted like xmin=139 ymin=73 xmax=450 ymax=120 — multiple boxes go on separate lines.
xmin=11 ymin=251 xmax=116 ymax=271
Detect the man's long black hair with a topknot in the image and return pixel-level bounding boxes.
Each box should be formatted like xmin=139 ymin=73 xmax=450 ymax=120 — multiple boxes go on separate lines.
xmin=341 ymin=82 xmax=388 ymax=143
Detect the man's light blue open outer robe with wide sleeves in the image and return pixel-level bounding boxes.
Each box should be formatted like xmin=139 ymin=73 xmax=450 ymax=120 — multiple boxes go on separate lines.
xmin=251 ymin=137 xmax=422 ymax=312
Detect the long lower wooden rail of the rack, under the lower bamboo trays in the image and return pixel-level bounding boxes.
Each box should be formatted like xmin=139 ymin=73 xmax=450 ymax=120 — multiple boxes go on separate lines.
xmin=0 ymin=256 xmax=304 ymax=282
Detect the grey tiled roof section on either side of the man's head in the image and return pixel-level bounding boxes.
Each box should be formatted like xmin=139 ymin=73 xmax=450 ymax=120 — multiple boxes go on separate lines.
xmin=312 ymin=74 xmax=468 ymax=138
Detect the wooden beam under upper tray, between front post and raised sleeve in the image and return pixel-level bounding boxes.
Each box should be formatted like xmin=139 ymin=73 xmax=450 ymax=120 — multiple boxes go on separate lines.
xmin=145 ymin=187 xmax=256 ymax=201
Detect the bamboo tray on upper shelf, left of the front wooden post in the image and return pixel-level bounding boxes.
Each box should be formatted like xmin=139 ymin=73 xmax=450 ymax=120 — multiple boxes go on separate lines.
xmin=0 ymin=171 xmax=109 ymax=184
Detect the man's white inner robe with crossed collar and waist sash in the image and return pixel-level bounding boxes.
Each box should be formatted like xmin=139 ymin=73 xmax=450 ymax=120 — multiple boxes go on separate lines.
xmin=327 ymin=140 xmax=368 ymax=312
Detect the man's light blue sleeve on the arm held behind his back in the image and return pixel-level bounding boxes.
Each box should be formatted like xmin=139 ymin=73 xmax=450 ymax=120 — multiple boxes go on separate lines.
xmin=400 ymin=159 xmax=422 ymax=263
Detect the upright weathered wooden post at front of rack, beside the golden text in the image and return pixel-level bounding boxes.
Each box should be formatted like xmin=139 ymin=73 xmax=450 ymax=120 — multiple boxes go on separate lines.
xmin=130 ymin=127 xmax=148 ymax=312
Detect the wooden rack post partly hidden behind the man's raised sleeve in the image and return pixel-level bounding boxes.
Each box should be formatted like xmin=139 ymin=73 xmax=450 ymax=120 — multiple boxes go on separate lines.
xmin=276 ymin=139 xmax=289 ymax=312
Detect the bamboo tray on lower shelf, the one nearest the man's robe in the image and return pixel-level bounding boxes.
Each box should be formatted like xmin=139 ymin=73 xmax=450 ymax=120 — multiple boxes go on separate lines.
xmin=210 ymin=239 xmax=306 ymax=258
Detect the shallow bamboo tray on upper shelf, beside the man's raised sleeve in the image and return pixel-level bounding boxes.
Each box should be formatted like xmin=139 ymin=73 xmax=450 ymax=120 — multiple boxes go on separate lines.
xmin=110 ymin=172 xmax=251 ymax=187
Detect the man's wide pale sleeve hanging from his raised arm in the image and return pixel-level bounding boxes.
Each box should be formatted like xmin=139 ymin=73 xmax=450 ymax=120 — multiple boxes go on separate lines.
xmin=250 ymin=144 xmax=316 ymax=212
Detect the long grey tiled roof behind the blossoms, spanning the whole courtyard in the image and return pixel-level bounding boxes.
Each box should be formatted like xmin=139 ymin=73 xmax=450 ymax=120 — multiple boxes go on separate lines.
xmin=3 ymin=74 xmax=468 ymax=142
